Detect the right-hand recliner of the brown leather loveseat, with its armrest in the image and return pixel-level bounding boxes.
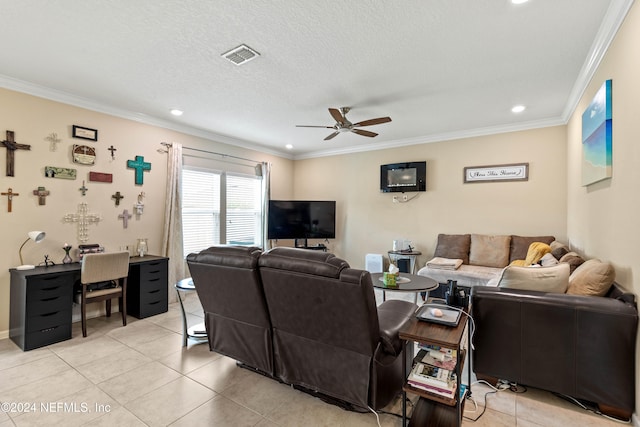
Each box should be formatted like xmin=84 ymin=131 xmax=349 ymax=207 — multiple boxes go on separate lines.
xmin=259 ymin=247 xmax=417 ymax=409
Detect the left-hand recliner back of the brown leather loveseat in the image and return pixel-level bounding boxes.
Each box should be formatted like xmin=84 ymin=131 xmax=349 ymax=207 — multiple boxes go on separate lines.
xmin=187 ymin=246 xmax=273 ymax=375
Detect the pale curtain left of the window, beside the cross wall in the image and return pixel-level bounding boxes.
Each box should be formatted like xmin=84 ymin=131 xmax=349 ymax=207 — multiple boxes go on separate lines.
xmin=162 ymin=142 xmax=187 ymax=302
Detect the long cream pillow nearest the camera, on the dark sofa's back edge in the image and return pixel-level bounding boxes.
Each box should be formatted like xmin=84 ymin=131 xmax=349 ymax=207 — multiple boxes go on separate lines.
xmin=498 ymin=264 xmax=569 ymax=293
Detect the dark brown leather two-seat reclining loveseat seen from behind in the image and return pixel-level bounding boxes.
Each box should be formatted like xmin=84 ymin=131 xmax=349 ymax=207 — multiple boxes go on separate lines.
xmin=187 ymin=247 xmax=417 ymax=410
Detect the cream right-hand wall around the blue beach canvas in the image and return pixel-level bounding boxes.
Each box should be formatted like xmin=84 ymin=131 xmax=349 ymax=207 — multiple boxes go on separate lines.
xmin=567 ymin=3 xmax=640 ymax=425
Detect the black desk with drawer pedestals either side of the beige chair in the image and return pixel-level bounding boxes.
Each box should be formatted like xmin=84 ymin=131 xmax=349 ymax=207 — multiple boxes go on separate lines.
xmin=9 ymin=255 xmax=169 ymax=351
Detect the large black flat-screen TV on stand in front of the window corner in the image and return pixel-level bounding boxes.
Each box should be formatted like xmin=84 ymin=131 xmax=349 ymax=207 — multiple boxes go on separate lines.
xmin=267 ymin=200 xmax=336 ymax=239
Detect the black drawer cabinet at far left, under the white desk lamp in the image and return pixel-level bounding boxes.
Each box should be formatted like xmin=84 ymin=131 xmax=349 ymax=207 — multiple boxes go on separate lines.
xmin=9 ymin=265 xmax=80 ymax=350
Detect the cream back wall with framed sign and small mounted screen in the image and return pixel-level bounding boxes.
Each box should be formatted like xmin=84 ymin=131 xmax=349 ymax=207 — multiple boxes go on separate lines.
xmin=294 ymin=126 xmax=566 ymax=268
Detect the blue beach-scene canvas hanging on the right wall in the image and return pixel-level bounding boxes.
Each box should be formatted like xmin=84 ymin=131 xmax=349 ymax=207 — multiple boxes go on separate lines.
xmin=582 ymin=80 xmax=612 ymax=186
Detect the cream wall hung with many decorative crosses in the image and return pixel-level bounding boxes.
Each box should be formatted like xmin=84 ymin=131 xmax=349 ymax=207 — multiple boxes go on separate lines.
xmin=0 ymin=89 xmax=293 ymax=338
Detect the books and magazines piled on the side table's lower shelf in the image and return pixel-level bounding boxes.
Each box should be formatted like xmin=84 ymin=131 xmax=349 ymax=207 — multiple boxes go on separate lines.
xmin=407 ymin=345 xmax=466 ymax=399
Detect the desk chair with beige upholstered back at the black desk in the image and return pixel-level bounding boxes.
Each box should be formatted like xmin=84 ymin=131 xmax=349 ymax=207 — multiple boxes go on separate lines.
xmin=80 ymin=252 xmax=129 ymax=337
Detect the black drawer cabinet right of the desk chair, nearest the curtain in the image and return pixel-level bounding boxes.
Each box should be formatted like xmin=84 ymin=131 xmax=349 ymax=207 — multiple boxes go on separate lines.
xmin=127 ymin=255 xmax=169 ymax=319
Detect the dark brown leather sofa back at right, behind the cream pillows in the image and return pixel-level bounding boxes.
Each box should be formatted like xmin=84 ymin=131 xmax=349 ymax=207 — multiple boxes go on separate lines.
xmin=471 ymin=283 xmax=638 ymax=419
